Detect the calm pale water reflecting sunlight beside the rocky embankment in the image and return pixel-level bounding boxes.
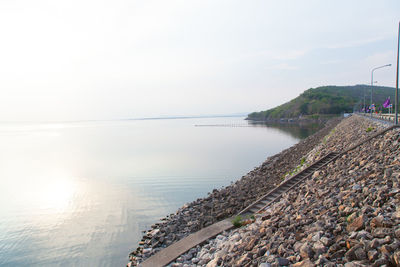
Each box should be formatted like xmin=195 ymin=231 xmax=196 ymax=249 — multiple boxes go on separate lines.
xmin=0 ymin=118 xmax=316 ymax=266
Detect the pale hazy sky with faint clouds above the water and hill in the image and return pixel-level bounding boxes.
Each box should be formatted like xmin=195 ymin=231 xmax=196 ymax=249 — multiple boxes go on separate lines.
xmin=0 ymin=0 xmax=400 ymax=121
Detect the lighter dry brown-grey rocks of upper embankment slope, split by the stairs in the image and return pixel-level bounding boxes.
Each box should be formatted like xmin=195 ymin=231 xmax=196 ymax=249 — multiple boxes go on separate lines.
xmin=171 ymin=116 xmax=400 ymax=267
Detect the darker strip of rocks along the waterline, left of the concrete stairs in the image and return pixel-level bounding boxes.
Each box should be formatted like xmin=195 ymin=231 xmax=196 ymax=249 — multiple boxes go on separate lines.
xmin=129 ymin=119 xmax=340 ymax=266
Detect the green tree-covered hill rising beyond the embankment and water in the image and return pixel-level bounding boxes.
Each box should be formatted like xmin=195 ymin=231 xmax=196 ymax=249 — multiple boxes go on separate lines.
xmin=247 ymin=85 xmax=395 ymax=120
